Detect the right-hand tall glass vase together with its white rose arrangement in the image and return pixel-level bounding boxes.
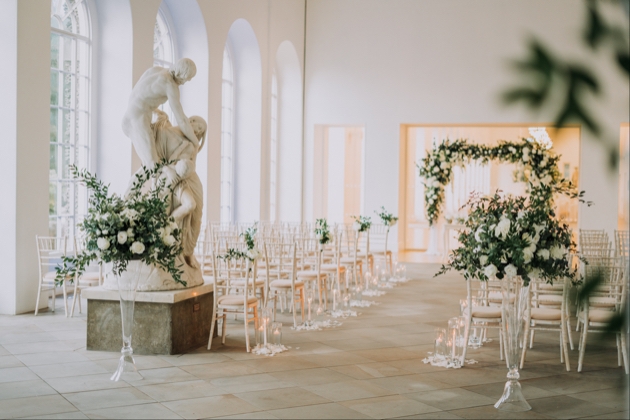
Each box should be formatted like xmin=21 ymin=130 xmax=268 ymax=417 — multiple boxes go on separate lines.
xmin=436 ymin=192 xmax=578 ymax=411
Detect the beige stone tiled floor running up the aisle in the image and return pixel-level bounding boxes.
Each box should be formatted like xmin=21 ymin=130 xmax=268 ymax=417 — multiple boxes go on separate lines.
xmin=0 ymin=264 xmax=629 ymax=419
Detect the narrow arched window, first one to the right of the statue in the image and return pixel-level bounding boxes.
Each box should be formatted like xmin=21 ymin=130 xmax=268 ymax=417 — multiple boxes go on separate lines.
xmin=221 ymin=43 xmax=234 ymax=222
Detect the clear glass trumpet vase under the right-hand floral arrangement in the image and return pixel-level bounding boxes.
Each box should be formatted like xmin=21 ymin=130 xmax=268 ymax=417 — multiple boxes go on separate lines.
xmin=494 ymin=277 xmax=532 ymax=412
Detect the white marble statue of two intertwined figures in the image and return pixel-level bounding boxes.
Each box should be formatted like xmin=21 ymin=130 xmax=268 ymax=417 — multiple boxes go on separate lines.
xmin=104 ymin=58 xmax=207 ymax=291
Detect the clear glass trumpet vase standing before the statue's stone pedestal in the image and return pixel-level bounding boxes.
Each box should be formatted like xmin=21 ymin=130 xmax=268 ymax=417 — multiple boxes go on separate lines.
xmin=110 ymin=260 xmax=151 ymax=381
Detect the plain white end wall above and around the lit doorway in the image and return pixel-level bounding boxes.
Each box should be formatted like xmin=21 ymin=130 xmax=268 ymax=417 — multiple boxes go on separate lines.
xmin=304 ymin=0 xmax=629 ymax=246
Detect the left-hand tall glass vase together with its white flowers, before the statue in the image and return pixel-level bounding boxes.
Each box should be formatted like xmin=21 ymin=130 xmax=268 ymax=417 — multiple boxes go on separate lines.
xmin=55 ymin=161 xmax=186 ymax=381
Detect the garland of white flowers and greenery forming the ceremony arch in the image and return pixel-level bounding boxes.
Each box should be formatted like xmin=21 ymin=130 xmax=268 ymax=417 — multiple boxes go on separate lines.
xmin=418 ymin=139 xmax=583 ymax=225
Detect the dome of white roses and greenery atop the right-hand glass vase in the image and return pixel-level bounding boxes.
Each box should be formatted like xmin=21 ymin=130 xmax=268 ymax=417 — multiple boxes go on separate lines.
xmin=436 ymin=193 xmax=577 ymax=284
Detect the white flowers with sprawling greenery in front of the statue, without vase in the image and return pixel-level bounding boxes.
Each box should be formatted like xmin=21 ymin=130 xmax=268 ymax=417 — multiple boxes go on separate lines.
xmin=55 ymin=161 xmax=186 ymax=286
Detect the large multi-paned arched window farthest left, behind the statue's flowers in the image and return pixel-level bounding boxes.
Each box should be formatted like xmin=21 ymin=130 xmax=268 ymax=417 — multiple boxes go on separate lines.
xmin=49 ymin=0 xmax=92 ymax=236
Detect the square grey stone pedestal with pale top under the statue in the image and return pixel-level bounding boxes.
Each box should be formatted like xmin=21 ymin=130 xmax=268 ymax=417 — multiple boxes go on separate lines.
xmin=81 ymin=281 xmax=214 ymax=355
